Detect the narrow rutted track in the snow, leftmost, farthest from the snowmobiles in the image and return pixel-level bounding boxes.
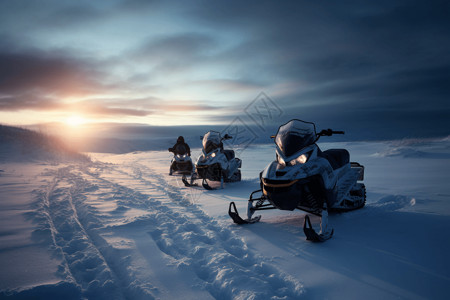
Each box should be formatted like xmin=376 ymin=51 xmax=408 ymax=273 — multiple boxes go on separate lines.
xmin=35 ymin=168 xmax=123 ymax=298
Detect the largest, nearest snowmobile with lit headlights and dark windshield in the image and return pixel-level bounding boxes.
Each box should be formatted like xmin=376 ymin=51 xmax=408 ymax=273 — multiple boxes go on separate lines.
xmin=228 ymin=119 xmax=366 ymax=242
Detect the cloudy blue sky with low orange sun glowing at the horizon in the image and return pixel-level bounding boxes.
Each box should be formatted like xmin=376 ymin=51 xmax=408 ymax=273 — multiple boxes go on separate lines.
xmin=0 ymin=0 xmax=450 ymax=137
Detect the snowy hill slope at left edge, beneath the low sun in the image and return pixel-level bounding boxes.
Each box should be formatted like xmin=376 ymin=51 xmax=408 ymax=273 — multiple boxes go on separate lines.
xmin=0 ymin=125 xmax=90 ymax=162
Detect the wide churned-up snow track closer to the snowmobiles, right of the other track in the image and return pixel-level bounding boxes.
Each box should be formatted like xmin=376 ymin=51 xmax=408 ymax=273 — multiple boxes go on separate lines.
xmin=103 ymin=163 xmax=303 ymax=299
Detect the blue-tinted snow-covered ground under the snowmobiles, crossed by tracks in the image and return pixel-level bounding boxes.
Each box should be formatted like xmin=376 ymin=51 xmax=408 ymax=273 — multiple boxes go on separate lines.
xmin=0 ymin=138 xmax=450 ymax=299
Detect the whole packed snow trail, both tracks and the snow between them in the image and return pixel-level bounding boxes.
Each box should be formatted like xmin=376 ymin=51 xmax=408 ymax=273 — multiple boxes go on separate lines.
xmin=28 ymin=163 xmax=303 ymax=299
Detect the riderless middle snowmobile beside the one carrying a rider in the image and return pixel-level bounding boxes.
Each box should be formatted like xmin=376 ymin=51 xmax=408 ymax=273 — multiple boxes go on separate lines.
xmin=183 ymin=131 xmax=242 ymax=190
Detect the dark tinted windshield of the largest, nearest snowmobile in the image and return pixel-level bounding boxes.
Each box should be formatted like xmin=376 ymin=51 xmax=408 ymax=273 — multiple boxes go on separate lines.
xmin=275 ymin=120 xmax=316 ymax=157
